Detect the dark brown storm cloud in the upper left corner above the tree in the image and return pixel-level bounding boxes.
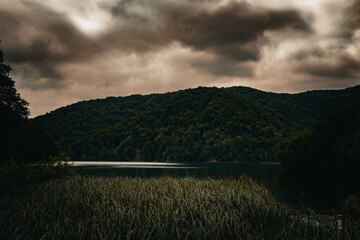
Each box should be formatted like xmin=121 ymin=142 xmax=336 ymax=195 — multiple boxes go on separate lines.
xmin=0 ymin=3 xmax=100 ymax=88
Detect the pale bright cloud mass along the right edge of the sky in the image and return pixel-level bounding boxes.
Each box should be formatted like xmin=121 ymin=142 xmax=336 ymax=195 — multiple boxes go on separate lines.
xmin=282 ymin=0 xmax=360 ymax=81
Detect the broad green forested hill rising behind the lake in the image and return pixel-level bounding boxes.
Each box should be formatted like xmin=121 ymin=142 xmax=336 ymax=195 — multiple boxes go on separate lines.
xmin=32 ymin=86 xmax=360 ymax=161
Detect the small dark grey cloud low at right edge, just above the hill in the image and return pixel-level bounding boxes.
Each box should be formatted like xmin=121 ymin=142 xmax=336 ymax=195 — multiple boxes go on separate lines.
xmin=296 ymin=55 xmax=360 ymax=79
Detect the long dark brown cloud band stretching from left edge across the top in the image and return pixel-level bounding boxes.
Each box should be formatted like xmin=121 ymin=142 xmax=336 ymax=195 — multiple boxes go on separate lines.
xmin=0 ymin=0 xmax=310 ymax=86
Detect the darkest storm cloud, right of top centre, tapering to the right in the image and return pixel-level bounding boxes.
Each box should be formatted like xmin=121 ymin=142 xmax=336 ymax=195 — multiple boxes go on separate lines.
xmin=167 ymin=2 xmax=310 ymax=61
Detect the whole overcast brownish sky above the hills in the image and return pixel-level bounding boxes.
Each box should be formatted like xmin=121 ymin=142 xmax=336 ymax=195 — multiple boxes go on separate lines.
xmin=0 ymin=0 xmax=360 ymax=117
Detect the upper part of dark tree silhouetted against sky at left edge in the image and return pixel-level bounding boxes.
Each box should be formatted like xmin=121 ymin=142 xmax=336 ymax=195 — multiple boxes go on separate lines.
xmin=0 ymin=42 xmax=30 ymax=119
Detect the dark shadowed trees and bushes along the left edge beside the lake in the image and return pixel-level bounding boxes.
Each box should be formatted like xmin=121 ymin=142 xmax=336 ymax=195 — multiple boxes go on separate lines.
xmin=0 ymin=41 xmax=74 ymax=186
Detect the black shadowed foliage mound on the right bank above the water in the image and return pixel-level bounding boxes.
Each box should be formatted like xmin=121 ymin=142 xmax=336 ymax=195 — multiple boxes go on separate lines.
xmin=276 ymin=107 xmax=360 ymax=175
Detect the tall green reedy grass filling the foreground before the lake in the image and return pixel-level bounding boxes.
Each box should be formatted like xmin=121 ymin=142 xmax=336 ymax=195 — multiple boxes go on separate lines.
xmin=0 ymin=176 xmax=356 ymax=240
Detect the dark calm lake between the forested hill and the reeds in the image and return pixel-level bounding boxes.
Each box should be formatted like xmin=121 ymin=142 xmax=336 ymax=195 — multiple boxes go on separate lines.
xmin=71 ymin=161 xmax=360 ymax=210
